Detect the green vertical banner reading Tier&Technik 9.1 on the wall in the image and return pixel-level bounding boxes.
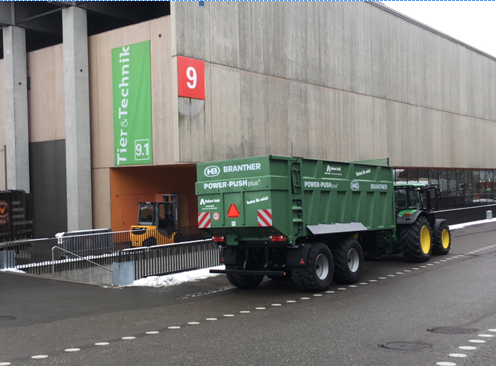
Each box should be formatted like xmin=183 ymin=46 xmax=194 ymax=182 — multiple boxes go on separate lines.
xmin=112 ymin=41 xmax=153 ymax=166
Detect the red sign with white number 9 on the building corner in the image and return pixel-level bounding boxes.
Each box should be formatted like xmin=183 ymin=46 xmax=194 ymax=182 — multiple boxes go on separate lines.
xmin=177 ymin=56 xmax=205 ymax=100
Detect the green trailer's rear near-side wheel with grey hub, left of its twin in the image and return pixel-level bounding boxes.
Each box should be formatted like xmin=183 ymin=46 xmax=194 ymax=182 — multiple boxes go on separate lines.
xmin=293 ymin=243 xmax=334 ymax=292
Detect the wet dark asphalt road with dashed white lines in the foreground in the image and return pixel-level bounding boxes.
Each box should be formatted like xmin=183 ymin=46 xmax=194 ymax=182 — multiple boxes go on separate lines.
xmin=0 ymin=224 xmax=496 ymax=366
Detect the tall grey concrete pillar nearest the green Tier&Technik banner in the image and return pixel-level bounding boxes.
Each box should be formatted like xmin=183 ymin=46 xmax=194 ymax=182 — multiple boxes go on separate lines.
xmin=62 ymin=6 xmax=93 ymax=231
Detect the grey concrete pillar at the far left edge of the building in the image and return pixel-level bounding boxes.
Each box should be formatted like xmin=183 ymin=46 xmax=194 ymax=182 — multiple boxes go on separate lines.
xmin=3 ymin=26 xmax=30 ymax=192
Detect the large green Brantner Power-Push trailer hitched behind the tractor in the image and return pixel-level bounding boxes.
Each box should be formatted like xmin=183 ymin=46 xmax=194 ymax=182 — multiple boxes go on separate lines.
xmin=196 ymin=155 xmax=449 ymax=291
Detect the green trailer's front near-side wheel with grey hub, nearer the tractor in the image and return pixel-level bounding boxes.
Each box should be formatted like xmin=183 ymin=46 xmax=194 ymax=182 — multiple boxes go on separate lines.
xmin=332 ymin=238 xmax=363 ymax=284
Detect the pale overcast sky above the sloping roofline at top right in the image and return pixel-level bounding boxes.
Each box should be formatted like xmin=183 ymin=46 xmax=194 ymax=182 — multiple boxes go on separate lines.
xmin=383 ymin=1 xmax=496 ymax=57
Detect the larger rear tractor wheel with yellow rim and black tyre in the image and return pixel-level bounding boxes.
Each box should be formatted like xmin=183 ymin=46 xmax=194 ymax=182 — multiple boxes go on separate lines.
xmin=400 ymin=216 xmax=432 ymax=262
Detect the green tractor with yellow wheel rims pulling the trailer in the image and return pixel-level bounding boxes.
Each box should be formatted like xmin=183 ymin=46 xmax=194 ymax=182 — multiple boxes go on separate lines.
xmin=394 ymin=183 xmax=451 ymax=262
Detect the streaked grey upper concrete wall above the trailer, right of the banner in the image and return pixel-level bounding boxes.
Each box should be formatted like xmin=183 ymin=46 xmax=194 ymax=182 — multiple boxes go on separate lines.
xmin=171 ymin=2 xmax=496 ymax=168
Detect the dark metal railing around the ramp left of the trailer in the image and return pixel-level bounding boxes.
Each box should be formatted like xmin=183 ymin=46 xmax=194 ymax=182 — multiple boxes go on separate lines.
xmin=0 ymin=228 xmax=219 ymax=284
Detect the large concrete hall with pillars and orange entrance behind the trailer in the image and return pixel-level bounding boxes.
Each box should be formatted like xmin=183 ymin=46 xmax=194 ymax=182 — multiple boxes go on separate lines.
xmin=0 ymin=2 xmax=496 ymax=236
